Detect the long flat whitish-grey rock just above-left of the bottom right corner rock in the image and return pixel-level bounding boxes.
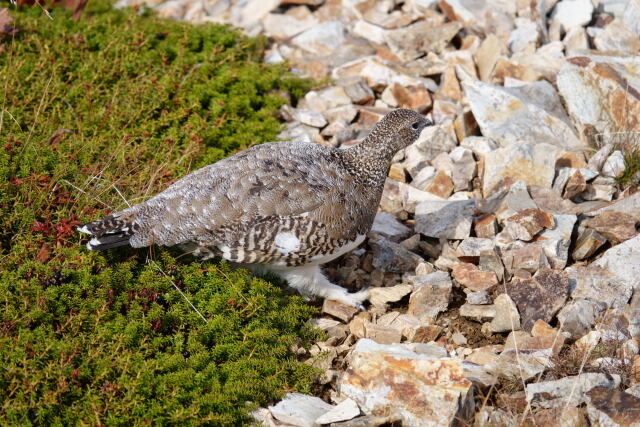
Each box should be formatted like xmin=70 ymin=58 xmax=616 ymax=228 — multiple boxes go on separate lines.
xmin=526 ymin=372 xmax=620 ymax=408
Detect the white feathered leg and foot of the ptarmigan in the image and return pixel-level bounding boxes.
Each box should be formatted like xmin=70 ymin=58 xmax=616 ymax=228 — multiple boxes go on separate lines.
xmin=274 ymin=265 xmax=369 ymax=308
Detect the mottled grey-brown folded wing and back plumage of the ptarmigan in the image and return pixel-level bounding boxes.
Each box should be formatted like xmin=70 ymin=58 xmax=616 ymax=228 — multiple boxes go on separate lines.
xmin=125 ymin=143 xmax=345 ymax=246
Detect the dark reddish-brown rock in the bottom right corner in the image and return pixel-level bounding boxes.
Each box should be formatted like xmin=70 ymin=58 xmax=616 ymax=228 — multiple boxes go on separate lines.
xmin=587 ymin=387 xmax=640 ymax=427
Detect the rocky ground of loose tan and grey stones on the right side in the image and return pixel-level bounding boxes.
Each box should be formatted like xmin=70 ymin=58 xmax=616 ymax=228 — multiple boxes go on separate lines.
xmin=112 ymin=0 xmax=640 ymax=426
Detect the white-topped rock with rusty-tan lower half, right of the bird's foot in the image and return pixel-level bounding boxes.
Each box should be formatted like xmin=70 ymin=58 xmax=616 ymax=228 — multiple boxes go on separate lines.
xmin=407 ymin=271 xmax=453 ymax=321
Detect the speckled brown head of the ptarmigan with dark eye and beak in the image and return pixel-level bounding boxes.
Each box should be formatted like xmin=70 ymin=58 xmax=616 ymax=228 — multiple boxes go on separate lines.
xmin=367 ymin=109 xmax=433 ymax=157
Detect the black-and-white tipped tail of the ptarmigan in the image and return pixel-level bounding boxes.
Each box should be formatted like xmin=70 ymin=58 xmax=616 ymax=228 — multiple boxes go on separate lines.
xmin=78 ymin=215 xmax=137 ymax=251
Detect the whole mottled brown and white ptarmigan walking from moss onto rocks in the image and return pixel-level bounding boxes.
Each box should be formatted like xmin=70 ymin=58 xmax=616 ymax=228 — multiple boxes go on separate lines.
xmin=79 ymin=109 xmax=431 ymax=306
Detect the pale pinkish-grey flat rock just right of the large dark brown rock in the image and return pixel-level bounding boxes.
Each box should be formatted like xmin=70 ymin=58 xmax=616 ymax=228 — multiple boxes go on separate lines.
xmin=565 ymin=265 xmax=633 ymax=308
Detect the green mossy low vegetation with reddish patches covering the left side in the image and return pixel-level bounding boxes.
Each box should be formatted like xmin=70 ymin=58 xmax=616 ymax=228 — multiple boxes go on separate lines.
xmin=0 ymin=0 xmax=316 ymax=425
